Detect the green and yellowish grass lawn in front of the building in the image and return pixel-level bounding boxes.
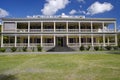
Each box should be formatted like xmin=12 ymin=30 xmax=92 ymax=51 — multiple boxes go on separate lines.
xmin=0 ymin=54 xmax=120 ymax=80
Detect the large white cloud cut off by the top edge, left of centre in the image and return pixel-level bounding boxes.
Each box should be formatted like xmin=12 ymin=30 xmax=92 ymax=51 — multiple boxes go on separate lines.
xmin=41 ymin=0 xmax=70 ymax=15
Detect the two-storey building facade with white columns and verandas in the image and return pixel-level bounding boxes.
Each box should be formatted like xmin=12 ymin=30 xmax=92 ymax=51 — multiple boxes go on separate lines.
xmin=1 ymin=16 xmax=117 ymax=50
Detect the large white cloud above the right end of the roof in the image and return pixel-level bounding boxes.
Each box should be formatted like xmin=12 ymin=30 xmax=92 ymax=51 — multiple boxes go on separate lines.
xmin=87 ymin=1 xmax=113 ymax=15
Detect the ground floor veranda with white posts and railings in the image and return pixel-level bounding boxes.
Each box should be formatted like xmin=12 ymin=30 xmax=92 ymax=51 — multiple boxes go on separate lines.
xmin=1 ymin=34 xmax=117 ymax=47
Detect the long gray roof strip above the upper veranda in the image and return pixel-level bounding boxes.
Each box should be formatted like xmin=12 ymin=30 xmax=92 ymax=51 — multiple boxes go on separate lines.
xmin=2 ymin=18 xmax=116 ymax=21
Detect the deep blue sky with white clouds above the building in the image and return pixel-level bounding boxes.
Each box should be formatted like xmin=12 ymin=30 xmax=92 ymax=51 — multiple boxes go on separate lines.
xmin=0 ymin=0 xmax=120 ymax=29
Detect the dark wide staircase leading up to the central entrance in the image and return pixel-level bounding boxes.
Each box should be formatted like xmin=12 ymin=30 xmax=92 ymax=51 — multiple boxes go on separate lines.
xmin=47 ymin=46 xmax=74 ymax=52
